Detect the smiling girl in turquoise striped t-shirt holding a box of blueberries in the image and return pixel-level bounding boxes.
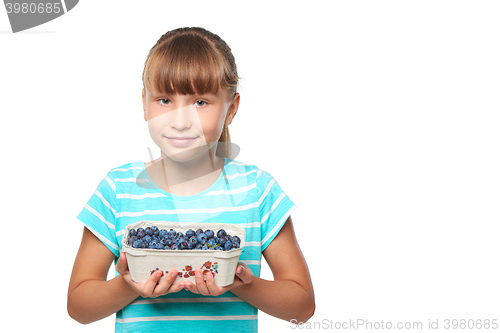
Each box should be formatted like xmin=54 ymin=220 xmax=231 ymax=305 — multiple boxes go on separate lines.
xmin=68 ymin=28 xmax=315 ymax=332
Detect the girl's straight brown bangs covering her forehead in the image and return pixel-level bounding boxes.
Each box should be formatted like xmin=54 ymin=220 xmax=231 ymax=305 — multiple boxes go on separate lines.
xmin=143 ymin=34 xmax=234 ymax=95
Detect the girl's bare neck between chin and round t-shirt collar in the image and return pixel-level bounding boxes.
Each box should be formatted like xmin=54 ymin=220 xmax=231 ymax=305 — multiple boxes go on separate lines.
xmin=146 ymin=149 xmax=224 ymax=196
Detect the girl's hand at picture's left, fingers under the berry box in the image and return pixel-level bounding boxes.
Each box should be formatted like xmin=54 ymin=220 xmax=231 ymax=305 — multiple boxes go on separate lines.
xmin=116 ymin=252 xmax=184 ymax=298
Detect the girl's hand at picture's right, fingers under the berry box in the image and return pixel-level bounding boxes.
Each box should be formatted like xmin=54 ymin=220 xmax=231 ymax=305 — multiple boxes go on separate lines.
xmin=182 ymin=263 xmax=254 ymax=296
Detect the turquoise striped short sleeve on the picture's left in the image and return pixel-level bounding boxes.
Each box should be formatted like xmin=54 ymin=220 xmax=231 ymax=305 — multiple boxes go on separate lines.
xmin=77 ymin=172 xmax=120 ymax=257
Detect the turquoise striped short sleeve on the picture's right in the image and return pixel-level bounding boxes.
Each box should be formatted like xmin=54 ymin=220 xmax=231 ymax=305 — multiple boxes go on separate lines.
xmin=257 ymin=170 xmax=297 ymax=251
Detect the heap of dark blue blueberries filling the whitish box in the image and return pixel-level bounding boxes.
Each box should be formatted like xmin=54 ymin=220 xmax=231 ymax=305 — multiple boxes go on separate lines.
xmin=127 ymin=226 xmax=241 ymax=251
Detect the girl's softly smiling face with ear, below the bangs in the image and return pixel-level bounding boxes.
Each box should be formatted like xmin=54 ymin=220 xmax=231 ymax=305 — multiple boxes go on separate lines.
xmin=142 ymin=89 xmax=240 ymax=162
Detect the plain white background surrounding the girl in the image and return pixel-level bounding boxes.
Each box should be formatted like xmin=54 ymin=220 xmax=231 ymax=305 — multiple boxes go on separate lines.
xmin=0 ymin=0 xmax=500 ymax=332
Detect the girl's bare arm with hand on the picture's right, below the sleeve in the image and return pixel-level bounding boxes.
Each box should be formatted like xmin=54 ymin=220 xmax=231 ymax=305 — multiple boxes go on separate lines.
xmin=186 ymin=217 xmax=316 ymax=322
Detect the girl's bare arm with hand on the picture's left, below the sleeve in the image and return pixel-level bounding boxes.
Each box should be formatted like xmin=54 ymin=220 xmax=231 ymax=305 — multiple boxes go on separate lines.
xmin=68 ymin=228 xmax=182 ymax=324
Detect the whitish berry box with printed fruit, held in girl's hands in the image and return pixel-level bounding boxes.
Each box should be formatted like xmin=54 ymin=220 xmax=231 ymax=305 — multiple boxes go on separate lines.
xmin=122 ymin=221 xmax=245 ymax=287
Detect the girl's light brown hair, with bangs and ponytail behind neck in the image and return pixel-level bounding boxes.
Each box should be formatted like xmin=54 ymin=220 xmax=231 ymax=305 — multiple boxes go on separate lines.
xmin=142 ymin=27 xmax=239 ymax=158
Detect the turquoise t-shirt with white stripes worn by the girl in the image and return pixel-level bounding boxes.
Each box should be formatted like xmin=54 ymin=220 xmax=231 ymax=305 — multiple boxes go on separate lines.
xmin=78 ymin=158 xmax=296 ymax=333
